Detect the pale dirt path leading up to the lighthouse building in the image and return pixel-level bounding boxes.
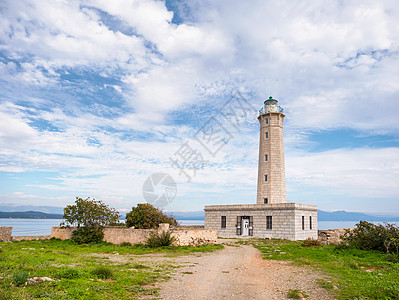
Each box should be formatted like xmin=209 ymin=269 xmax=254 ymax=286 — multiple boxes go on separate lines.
xmin=159 ymin=245 xmax=334 ymax=299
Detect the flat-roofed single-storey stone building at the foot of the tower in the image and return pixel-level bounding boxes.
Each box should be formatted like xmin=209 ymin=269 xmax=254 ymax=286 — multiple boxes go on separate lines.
xmin=204 ymin=203 xmax=317 ymax=241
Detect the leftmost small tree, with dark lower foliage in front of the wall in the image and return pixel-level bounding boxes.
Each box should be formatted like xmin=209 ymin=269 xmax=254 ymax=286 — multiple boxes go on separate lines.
xmin=60 ymin=197 xmax=120 ymax=244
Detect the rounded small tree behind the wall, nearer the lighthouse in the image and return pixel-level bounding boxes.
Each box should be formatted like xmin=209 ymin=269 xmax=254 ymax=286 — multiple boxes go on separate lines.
xmin=126 ymin=203 xmax=179 ymax=229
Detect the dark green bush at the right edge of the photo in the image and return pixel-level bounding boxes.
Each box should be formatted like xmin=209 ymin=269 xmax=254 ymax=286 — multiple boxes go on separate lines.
xmin=341 ymin=221 xmax=399 ymax=254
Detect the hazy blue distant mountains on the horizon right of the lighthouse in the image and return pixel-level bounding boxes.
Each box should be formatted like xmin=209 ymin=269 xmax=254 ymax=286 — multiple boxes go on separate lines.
xmin=317 ymin=210 xmax=399 ymax=222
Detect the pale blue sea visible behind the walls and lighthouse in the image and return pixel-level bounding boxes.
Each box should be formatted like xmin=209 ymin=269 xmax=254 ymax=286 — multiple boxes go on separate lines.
xmin=0 ymin=218 xmax=399 ymax=236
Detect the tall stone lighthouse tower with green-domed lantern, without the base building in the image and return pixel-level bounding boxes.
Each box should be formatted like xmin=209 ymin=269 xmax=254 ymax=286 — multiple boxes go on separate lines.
xmin=256 ymin=97 xmax=287 ymax=204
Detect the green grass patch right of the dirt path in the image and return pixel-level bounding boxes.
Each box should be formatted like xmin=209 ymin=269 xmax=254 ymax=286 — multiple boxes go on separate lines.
xmin=252 ymin=240 xmax=399 ymax=300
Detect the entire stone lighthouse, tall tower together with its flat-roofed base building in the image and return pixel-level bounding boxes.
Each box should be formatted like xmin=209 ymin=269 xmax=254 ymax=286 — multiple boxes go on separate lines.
xmin=205 ymin=97 xmax=317 ymax=240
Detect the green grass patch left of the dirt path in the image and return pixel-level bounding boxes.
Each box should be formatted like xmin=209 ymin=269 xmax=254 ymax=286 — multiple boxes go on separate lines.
xmin=0 ymin=239 xmax=223 ymax=300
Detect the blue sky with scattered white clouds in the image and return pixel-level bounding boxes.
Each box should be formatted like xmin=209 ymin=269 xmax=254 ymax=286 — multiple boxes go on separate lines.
xmin=0 ymin=0 xmax=399 ymax=215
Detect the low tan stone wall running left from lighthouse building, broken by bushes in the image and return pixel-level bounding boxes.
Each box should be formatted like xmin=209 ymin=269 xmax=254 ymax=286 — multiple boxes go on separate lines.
xmin=51 ymin=224 xmax=217 ymax=246
